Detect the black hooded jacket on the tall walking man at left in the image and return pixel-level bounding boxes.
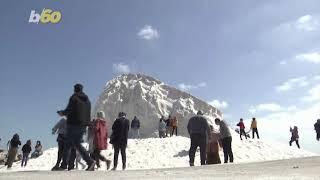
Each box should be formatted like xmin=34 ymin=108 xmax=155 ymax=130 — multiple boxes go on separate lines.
xmin=62 ymin=92 xmax=91 ymax=126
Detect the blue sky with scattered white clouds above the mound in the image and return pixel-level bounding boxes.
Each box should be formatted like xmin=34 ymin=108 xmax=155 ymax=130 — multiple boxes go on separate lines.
xmin=0 ymin=0 xmax=320 ymax=152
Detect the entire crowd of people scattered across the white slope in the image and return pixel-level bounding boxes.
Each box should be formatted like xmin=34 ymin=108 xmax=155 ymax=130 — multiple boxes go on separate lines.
xmin=2 ymin=84 xmax=320 ymax=171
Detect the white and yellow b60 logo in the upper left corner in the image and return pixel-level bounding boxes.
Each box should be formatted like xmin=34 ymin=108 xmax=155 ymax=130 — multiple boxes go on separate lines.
xmin=29 ymin=8 xmax=61 ymax=24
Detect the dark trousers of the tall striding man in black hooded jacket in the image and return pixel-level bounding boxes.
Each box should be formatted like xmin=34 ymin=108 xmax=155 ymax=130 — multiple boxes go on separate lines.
xmin=61 ymin=125 xmax=93 ymax=169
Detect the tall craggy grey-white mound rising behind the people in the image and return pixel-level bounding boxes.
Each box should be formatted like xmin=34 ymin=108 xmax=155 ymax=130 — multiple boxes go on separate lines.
xmin=94 ymin=74 xmax=222 ymax=137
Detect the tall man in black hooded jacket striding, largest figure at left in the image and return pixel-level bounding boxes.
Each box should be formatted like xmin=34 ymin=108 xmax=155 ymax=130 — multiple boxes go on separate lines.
xmin=59 ymin=84 xmax=95 ymax=171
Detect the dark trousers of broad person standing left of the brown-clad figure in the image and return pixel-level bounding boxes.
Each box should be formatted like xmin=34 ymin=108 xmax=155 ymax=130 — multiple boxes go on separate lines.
xmin=189 ymin=134 xmax=207 ymax=166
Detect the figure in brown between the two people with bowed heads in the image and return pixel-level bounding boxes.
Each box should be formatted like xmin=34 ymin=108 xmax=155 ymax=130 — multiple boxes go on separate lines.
xmin=207 ymin=125 xmax=221 ymax=164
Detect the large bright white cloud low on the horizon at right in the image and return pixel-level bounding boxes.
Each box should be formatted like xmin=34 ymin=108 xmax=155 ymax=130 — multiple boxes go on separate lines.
xmin=251 ymin=102 xmax=320 ymax=152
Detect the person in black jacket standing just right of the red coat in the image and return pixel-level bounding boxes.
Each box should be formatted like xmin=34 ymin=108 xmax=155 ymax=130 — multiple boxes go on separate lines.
xmin=110 ymin=112 xmax=130 ymax=170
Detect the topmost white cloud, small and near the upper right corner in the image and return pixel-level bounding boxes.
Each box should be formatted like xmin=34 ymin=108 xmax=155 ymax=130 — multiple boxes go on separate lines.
xmin=295 ymin=15 xmax=320 ymax=31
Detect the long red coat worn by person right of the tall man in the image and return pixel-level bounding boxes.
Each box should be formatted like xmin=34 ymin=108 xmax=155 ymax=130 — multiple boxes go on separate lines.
xmin=93 ymin=119 xmax=108 ymax=150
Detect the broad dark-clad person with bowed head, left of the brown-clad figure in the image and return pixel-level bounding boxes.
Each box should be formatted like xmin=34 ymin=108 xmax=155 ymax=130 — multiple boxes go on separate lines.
xmin=187 ymin=111 xmax=210 ymax=166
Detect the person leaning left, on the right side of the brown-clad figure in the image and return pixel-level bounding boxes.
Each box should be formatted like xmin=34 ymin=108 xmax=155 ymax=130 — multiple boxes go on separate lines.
xmin=214 ymin=118 xmax=233 ymax=163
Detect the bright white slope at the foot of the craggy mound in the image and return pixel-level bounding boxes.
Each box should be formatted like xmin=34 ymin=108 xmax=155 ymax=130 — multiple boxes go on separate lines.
xmin=0 ymin=136 xmax=316 ymax=172
